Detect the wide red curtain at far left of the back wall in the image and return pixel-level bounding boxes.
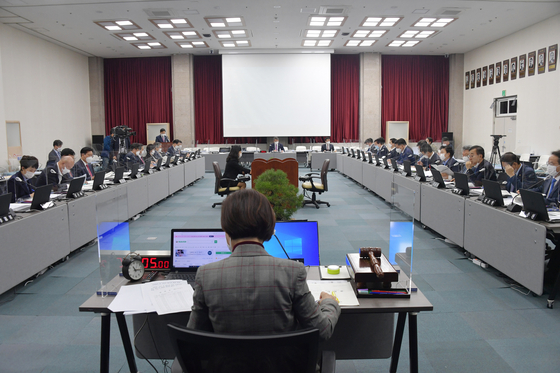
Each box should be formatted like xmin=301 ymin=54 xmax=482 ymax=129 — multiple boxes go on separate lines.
xmin=104 ymin=57 xmax=173 ymax=144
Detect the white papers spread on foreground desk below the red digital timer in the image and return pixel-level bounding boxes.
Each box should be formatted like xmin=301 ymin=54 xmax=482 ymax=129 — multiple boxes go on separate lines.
xmin=109 ymin=280 xmax=193 ymax=315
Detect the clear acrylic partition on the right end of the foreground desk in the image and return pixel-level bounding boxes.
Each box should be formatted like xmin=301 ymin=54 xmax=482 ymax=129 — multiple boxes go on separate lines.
xmin=387 ymin=183 xmax=416 ymax=293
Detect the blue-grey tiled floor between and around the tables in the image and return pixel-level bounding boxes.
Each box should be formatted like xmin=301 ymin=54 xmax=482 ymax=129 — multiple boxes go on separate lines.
xmin=0 ymin=170 xmax=560 ymax=373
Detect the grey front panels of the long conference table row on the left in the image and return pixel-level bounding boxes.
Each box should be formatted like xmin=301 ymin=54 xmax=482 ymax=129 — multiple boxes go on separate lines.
xmin=0 ymin=158 xmax=206 ymax=294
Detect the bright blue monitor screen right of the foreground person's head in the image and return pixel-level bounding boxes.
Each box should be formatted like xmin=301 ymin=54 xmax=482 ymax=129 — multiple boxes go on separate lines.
xmin=264 ymin=221 xmax=320 ymax=266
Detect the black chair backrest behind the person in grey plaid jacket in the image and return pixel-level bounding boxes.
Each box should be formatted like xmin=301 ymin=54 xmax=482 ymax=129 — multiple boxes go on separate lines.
xmin=167 ymin=324 xmax=319 ymax=373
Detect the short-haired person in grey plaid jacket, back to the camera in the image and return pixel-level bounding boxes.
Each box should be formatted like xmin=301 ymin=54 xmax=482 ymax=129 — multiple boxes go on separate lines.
xmin=187 ymin=189 xmax=340 ymax=346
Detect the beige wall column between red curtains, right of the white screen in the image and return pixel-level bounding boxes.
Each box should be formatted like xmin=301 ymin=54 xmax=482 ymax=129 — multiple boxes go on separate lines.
xmin=359 ymin=53 xmax=381 ymax=144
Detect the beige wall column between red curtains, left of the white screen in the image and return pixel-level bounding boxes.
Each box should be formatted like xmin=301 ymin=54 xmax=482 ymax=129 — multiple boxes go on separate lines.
xmin=171 ymin=54 xmax=195 ymax=148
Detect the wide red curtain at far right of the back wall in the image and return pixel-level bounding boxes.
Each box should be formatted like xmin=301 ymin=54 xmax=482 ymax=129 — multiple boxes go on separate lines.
xmin=381 ymin=56 xmax=449 ymax=141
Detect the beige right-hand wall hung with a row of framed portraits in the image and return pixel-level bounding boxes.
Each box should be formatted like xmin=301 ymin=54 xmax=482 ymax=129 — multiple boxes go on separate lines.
xmin=463 ymin=15 xmax=560 ymax=154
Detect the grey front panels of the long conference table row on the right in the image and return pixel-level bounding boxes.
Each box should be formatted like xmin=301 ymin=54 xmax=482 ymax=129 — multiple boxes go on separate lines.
xmin=337 ymin=154 xmax=560 ymax=295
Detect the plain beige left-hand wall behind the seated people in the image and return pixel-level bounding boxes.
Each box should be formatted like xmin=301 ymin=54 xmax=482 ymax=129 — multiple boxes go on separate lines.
xmin=0 ymin=24 xmax=91 ymax=164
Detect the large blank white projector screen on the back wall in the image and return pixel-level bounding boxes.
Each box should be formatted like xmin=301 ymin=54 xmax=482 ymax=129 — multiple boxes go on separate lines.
xmin=222 ymin=54 xmax=331 ymax=137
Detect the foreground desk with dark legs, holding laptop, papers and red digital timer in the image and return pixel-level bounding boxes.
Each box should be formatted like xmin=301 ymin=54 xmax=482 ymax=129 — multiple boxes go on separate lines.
xmin=79 ymin=267 xmax=433 ymax=373
